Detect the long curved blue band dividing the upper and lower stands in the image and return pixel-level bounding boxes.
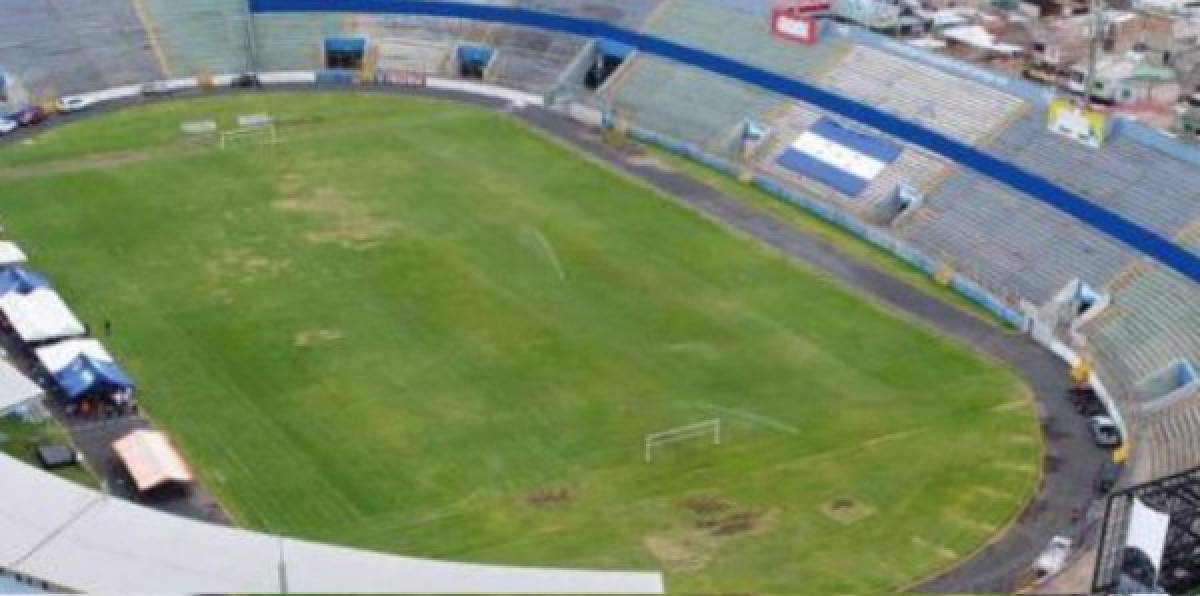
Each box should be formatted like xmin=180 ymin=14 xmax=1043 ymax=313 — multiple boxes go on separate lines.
xmin=250 ymin=0 xmax=1200 ymax=283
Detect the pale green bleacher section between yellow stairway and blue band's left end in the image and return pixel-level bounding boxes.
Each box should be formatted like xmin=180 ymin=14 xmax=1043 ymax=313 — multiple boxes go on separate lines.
xmin=139 ymin=0 xmax=251 ymax=77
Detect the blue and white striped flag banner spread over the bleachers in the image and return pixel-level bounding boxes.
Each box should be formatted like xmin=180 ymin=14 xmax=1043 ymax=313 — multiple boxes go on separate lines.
xmin=775 ymin=118 xmax=901 ymax=197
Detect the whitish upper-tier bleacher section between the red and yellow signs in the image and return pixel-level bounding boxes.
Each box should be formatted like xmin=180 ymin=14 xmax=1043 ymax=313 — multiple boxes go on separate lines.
xmin=818 ymin=46 xmax=1026 ymax=143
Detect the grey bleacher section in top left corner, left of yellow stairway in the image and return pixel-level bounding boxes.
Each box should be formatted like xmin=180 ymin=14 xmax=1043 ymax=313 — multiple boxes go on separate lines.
xmin=0 ymin=0 xmax=160 ymax=102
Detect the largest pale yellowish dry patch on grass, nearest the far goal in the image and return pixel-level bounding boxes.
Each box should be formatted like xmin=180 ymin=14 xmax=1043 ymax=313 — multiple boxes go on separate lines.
xmin=271 ymin=174 xmax=402 ymax=251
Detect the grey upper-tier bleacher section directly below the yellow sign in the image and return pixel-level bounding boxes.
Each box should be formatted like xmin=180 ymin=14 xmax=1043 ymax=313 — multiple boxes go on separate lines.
xmin=989 ymin=114 xmax=1200 ymax=236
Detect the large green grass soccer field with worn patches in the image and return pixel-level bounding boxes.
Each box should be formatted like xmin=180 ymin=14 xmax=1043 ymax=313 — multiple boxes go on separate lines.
xmin=0 ymin=94 xmax=1042 ymax=592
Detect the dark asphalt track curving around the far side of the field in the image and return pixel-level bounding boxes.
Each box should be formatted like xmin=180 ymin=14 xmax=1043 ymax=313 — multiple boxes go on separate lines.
xmin=0 ymin=86 xmax=1105 ymax=592
